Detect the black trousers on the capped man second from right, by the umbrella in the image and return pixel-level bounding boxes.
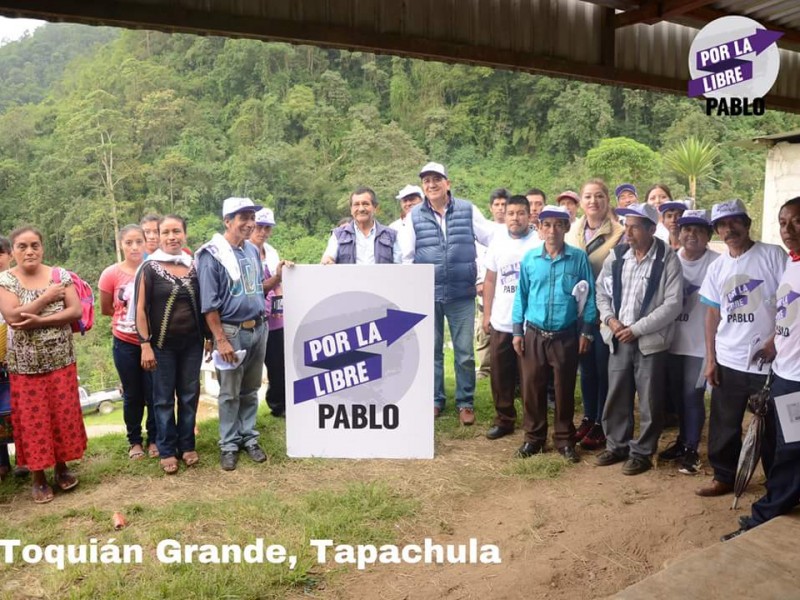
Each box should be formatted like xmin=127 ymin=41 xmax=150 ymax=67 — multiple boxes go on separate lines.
xmin=708 ymin=365 xmax=775 ymax=485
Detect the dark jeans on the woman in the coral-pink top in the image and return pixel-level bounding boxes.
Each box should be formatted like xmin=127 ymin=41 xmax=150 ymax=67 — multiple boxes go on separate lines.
xmin=112 ymin=338 xmax=156 ymax=446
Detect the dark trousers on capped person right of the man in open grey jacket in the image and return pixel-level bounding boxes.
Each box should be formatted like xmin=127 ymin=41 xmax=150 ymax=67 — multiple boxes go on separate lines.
xmin=665 ymin=354 xmax=706 ymax=451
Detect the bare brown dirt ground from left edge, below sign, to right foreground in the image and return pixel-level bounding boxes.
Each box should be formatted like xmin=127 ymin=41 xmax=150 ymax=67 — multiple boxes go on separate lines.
xmin=3 ymin=431 xmax=762 ymax=600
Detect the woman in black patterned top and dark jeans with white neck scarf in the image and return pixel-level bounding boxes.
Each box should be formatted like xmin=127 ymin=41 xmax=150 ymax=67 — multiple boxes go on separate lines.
xmin=136 ymin=215 xmax=204 ymax=475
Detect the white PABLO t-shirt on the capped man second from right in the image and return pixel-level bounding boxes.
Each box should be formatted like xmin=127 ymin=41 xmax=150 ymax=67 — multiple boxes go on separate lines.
xmin=700 ymin=242 xmax=786 ymax=374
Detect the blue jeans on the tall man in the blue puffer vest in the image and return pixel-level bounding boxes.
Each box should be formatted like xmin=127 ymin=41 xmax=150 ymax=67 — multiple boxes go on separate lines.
xmin=433 ymin=298 xmax=475 ymax=409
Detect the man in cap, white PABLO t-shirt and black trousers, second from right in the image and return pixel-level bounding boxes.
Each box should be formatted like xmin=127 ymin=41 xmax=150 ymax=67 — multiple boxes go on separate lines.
xmin=696 ymin=199 xmax=786 ymax=496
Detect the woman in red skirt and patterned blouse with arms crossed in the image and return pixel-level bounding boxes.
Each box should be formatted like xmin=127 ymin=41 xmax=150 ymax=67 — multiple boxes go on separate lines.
xmin=0 ymin=227 xmax=86 ymax=504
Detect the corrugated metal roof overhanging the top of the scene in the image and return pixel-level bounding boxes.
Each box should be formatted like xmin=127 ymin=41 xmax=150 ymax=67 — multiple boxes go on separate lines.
xmin=0 ymin=0 xmax=800 ymax=112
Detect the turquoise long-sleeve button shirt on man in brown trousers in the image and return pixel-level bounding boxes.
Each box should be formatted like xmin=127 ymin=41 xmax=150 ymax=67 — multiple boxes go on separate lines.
xmin=512 ymin=244 xmax=597 ymax=335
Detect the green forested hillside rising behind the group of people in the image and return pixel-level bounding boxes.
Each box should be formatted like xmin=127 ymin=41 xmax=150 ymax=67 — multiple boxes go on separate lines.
xmin=0 ymin=24 xmax=800 ymax=384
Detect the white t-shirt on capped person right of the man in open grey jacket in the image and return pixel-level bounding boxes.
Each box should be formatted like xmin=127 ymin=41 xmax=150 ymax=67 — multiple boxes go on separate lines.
xmin=669 ymin=248 xmax=719 ymax=358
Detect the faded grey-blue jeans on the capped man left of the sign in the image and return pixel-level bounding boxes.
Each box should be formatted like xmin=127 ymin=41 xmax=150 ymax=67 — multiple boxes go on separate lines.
xmin=217 ymin=323 xmax=269 ymax=452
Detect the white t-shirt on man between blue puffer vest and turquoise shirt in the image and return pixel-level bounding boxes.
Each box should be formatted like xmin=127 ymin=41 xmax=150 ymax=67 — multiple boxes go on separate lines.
xmin=484 ymin=229 xmax=543 ymax=333
